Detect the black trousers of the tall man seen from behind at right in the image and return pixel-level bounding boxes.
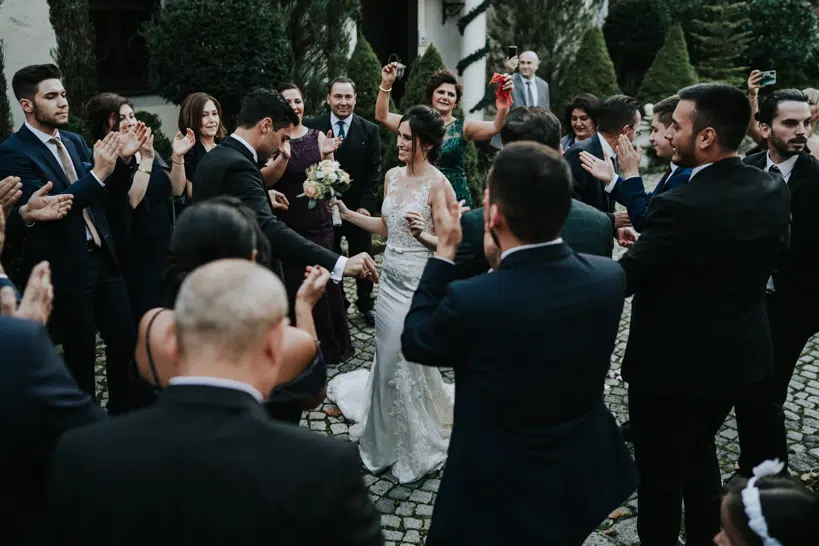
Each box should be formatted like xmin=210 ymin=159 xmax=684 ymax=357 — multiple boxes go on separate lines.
xmin=628 ymin=390 xmax=733 ymax=546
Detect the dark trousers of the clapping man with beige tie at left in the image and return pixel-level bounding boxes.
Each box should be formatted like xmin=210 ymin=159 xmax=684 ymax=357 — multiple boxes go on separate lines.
xmin=52 ymin=245 xmax=143 ymax=414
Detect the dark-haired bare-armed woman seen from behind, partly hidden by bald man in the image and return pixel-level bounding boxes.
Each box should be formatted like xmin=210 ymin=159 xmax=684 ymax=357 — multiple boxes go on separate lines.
xmin=137 ymin=196 xmax=330 ymax=424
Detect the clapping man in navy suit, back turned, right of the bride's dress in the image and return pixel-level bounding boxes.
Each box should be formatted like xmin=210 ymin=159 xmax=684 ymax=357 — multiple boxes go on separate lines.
xmin=401 ymin=142 xmax=637 ymax=546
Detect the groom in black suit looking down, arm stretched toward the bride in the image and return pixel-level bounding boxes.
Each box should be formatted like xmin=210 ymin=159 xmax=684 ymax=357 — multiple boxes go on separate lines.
xmin=193 ymin=89 xmax=378 ymax=282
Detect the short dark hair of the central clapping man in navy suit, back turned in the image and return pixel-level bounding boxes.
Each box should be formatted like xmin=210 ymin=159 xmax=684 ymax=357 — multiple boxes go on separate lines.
xmin=487 ymin=142 xmax=572 ymax=243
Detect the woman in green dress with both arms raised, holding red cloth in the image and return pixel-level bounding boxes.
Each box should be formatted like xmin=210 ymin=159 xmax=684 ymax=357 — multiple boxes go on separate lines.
xmin=375 ymin=63 xmax=513 ymax=207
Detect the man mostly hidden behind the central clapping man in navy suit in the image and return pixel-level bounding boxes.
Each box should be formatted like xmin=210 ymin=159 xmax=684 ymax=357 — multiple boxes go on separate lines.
xmin=455 ymin=106 xmax=614 ymax=279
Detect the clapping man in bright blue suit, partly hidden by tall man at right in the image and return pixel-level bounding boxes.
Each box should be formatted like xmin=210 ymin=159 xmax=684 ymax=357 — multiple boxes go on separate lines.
xmin=580 ymin=95 xmax=691 ymax=231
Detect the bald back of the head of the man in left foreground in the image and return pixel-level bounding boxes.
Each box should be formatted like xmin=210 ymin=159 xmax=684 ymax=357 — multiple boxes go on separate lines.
xmin=174 ymin=260 xmax=287 ymax=360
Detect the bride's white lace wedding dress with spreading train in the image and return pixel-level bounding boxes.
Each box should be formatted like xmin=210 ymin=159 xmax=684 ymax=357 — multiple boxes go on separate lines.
xmin=327 ymin=169 xmax=454 ymax=483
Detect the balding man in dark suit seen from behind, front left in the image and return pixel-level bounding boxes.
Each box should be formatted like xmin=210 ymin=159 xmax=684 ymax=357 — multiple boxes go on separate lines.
xmin=49 ymin=260 xmax=384 ymax=546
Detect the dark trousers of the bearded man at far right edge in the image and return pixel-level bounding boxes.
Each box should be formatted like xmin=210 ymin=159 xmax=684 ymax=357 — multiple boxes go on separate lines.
xmin=735 ymin=292 xmax=819 ymax=477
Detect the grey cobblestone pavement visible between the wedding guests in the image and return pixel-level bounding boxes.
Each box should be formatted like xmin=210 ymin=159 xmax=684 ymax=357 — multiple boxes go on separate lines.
xmin=94 ymin=172 xmax=819 ymax=546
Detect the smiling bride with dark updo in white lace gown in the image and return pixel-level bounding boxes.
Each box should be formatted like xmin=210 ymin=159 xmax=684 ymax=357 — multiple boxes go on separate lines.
xmin=327 ymin=106 xmax=454 ymax=483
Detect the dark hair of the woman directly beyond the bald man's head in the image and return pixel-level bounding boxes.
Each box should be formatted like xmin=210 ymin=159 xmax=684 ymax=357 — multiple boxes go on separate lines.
xmin=161 ymin=196 xmax=270 ymax=309
